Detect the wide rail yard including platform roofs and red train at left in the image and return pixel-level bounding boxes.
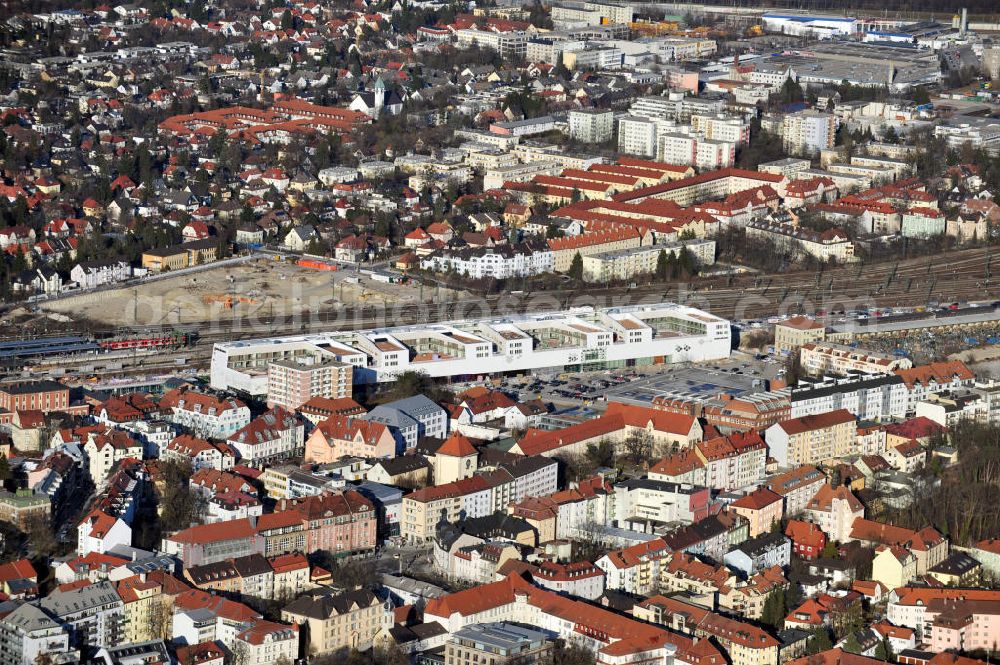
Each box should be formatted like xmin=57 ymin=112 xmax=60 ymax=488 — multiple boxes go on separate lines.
xmin=8 ymin=248 xmax=1000 ymax=378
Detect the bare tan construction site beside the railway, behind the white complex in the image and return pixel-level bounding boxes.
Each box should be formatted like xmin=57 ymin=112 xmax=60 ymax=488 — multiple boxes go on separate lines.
xmin=35 ymin=258 xmax=464 ymax=327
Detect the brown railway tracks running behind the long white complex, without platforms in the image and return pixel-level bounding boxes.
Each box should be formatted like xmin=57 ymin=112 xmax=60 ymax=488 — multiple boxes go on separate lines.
xmin=23 ymin=248 xmax=1000 ymax=376
